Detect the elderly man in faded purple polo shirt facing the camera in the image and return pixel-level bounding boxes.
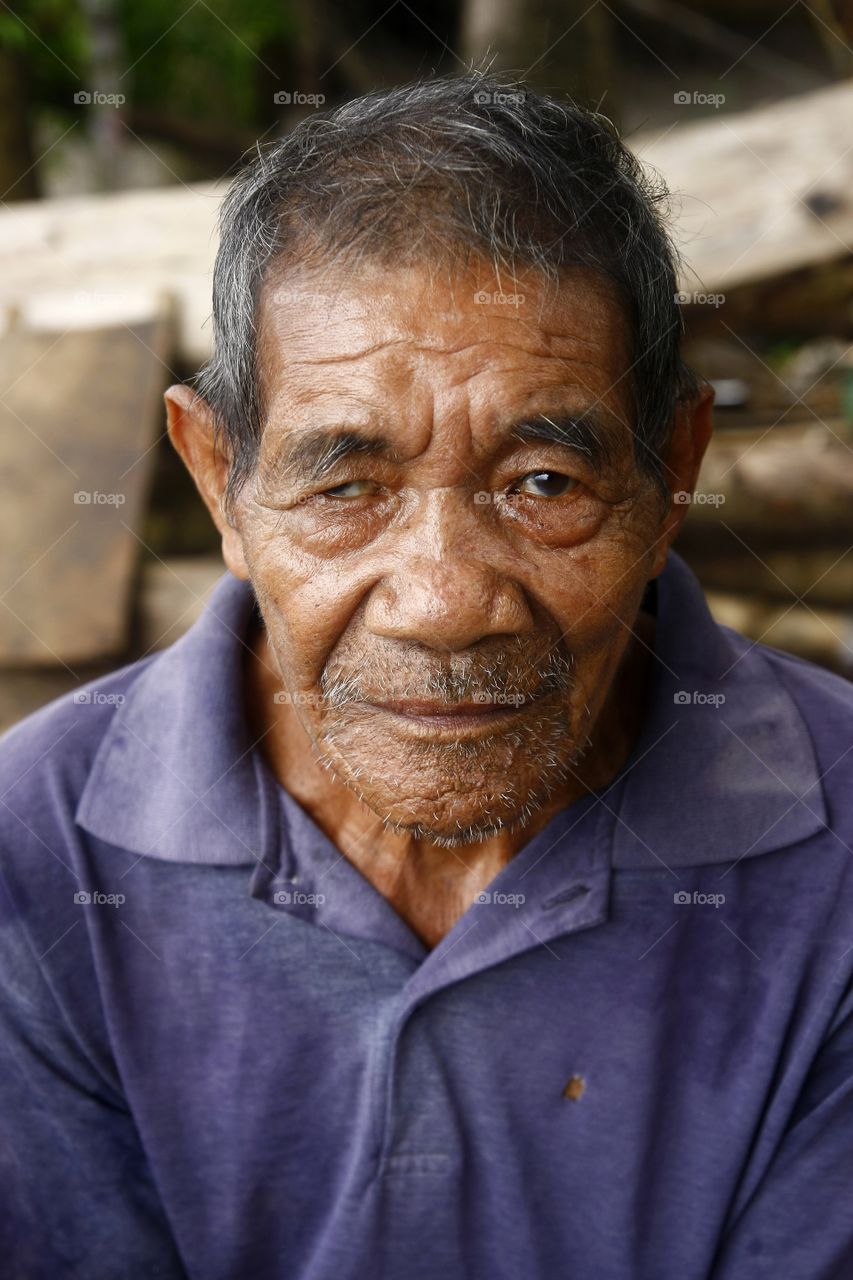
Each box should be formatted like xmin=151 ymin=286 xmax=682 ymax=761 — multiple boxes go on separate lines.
xmin=0 ymin=74 xmax=853 ymax=1280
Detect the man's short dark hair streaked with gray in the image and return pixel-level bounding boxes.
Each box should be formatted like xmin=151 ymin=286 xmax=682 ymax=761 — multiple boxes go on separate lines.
xmin=195 ymin=69 xmax=697 ymax=506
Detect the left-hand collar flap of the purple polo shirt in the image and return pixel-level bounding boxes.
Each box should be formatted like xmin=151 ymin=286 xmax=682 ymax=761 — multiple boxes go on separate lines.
xmin=76 ymin=573 xmax=273 ymax=865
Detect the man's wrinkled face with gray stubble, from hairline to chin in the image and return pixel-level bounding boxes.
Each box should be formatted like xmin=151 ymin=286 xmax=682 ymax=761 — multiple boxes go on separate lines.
xmin=216 ymin=256 xmax=663 ymax=844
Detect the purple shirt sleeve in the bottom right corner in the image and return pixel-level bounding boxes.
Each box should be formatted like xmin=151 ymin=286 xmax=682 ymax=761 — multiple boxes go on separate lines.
xmin=710 ymin=972 xmax=853 ymax=1280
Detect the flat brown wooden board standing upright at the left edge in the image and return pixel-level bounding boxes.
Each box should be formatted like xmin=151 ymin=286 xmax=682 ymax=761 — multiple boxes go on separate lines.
xmin=0 ymin=298 xmax=170 ymax=667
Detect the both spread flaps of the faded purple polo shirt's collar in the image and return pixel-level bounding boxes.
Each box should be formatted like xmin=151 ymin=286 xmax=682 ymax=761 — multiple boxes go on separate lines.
xmin=76 ymin=553 xmax=826 ymax=868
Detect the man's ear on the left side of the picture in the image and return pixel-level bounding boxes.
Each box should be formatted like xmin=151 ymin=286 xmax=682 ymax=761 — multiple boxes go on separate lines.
xmin=164 ymin=383 xmax=248 ymax=579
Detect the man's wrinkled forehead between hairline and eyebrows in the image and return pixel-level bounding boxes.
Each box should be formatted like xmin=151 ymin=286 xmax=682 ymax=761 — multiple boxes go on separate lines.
xmin=257 ymin=260 xmax=630 ymax=421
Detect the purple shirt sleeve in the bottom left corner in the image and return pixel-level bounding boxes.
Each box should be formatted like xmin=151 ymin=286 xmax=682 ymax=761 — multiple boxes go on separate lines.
xmin=0 ymin=876 xmax=186 ymax=1280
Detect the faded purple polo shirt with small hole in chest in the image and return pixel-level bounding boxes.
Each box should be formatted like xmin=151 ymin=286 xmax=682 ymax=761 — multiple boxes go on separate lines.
xmin=0 ymin=556 xmax=853 ymax=1280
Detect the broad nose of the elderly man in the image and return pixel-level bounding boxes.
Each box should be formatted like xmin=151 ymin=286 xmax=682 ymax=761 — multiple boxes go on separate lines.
xmin=364 ymin=491 xmax=534 ymax=653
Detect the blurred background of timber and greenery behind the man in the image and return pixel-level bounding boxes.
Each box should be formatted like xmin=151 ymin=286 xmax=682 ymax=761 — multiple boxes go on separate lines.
xmin=0 ymin=0 xmax=853 ymax=727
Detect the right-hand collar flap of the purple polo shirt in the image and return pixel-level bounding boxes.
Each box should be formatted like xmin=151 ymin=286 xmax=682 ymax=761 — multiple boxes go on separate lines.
xmin=605 ymin=553 xmax=827 ymax=869
